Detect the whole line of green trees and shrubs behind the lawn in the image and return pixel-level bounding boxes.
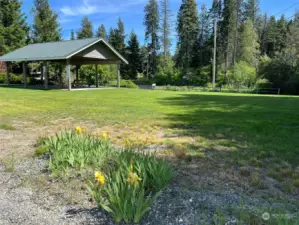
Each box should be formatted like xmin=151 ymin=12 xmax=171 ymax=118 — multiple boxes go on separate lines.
xmin=0 ymin=0 xmax=299 ymax=94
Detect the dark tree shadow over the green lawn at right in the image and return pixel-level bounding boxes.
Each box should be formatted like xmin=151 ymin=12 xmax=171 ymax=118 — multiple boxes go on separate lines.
xmin=160 ymin=94 xmax=299 ymax=162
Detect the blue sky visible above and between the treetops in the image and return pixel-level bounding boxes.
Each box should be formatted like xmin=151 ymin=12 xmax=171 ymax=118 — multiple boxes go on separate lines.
xmin=23 ymin=0 xmax=299 ymax=48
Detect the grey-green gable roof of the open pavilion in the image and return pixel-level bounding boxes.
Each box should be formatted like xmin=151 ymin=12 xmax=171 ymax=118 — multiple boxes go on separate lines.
xmin=0 ymin=38 xmax=128 ymax=64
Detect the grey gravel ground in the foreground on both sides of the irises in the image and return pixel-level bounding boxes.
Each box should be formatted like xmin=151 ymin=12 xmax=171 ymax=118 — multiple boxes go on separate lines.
xmin=0 ymin=159 xmax=298 ymax=225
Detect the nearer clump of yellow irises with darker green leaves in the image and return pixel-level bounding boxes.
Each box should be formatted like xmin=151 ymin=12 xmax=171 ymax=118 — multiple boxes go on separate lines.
xmin=85 ymin=149 xmax=174 ymax=223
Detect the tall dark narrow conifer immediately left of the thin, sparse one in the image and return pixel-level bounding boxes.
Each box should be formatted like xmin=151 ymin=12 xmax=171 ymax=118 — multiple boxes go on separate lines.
xmin=144 ymin=0 xmax=160 ymax=76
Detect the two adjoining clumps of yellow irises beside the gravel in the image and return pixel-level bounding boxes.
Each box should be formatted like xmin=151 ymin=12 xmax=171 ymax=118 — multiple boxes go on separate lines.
xmin=42 ymin=127 xmax=175 ymax=223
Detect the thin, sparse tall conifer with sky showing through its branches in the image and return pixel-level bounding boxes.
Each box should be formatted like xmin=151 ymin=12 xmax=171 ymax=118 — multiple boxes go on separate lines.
xmin=160 ymin=0 xmax=172 ymax=61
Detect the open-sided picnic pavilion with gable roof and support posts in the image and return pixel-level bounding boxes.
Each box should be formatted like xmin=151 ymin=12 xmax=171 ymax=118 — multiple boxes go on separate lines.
xmin=0 ymin=38 xmax=128 ymax=90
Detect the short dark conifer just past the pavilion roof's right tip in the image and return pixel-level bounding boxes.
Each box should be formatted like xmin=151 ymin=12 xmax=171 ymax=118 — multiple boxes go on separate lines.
xmin=127 ymin=31 xmax=142 ymax=80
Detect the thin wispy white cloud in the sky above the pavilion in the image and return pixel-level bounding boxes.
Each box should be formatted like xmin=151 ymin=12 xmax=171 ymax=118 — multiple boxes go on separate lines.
xmin=60 ymin=0 xmax=146 ymax=16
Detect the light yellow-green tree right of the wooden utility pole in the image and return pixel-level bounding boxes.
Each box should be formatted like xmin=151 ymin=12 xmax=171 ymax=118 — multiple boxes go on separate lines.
xmin=239 ymin=20 xmax=260 ymax=68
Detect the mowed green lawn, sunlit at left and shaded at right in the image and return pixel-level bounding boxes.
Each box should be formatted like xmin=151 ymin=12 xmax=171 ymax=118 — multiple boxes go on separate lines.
xmin=0 ymin=88 xmax=299 ymax=163
